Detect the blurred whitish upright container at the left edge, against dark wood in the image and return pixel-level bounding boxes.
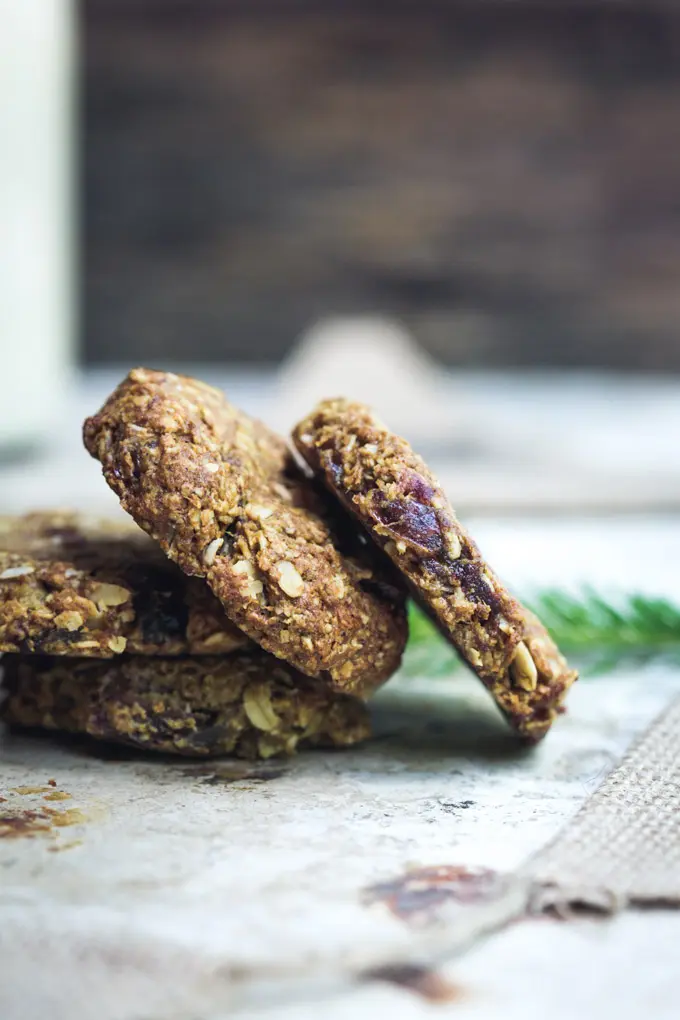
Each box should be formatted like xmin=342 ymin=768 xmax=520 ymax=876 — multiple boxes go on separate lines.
xmin=0 ymin=0 xmax=75 ymax=458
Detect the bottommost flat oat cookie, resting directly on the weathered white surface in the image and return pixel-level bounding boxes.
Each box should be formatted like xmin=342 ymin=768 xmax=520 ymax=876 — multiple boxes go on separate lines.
xmin=0 ymin=649 xmax=369 ymax=758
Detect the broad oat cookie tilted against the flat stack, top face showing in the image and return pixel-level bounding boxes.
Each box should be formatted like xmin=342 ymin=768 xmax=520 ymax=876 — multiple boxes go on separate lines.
xmin=84 ymin=369 xmax=407 ymax=695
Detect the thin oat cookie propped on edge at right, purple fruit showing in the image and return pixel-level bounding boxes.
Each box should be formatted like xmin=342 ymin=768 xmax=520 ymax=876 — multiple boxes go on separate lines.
xmin=294 ymin=400 xmax=577 ymax=740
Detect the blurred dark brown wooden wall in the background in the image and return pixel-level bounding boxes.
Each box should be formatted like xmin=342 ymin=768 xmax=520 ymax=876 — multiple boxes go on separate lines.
xmin=82 ymin=0 xmax=680 ymax=369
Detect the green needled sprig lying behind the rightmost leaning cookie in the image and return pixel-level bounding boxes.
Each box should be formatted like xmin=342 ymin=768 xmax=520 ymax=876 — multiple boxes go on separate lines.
xmin=404 ymin=589 xmax=680 ymax=677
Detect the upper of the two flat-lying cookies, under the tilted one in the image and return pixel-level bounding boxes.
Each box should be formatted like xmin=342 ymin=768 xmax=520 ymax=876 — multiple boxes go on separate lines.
xmin=0 ymin=511 xmax=249 ymax=658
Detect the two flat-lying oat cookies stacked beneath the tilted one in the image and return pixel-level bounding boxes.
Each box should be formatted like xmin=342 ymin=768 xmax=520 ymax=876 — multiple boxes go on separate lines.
xmin=0 ymin=514 xmax=375 ymax=757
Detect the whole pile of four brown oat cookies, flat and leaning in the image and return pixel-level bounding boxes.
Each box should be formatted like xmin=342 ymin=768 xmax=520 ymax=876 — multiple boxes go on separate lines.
xmin=0 ymin=369 xmax=575 ymax=757
